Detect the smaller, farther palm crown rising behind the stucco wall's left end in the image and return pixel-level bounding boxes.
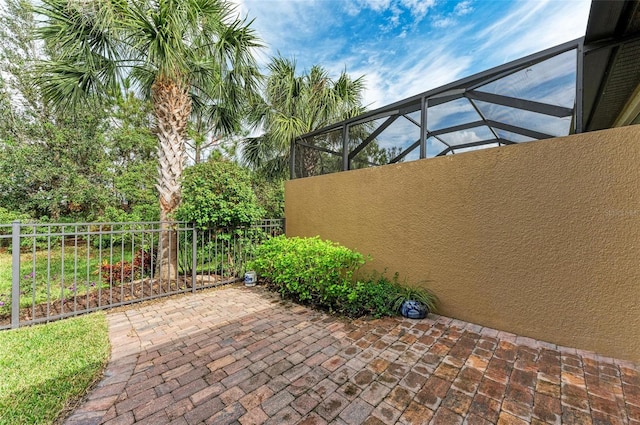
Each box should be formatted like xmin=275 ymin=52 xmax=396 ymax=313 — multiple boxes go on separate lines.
xmin=242 ymin=56 xmax=364 ymax=179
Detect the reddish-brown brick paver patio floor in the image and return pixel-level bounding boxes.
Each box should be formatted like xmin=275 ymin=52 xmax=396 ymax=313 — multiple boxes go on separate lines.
xmin=66 ymin=286 xmax=640 ymax=425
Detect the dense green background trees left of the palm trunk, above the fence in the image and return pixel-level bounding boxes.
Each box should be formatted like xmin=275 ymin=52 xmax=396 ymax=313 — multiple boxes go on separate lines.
xmin=0 ymin=0 xmax=159 ymax=221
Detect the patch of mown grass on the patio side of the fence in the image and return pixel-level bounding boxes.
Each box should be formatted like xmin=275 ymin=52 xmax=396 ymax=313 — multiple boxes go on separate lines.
xmin=0 ymin=312 xmax=109 ymax=425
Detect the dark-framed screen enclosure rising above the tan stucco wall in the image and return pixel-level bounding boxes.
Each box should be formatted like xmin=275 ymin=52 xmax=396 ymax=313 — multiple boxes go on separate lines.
xmin=292 ymin=39 xmax=582 ymax=176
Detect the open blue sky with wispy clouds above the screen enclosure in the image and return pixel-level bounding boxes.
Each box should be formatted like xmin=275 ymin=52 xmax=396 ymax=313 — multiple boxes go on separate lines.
xmin=234 ymin=0 xmax=591 ymax=109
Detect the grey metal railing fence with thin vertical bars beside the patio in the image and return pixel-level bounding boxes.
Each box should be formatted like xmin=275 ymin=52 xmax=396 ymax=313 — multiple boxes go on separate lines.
xmin=0 ymin=219 xmax=284 ymax=330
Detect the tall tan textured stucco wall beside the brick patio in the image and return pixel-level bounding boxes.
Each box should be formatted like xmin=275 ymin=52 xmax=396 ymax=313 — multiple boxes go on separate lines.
xmin=285 ymin=126 xmax=640 ymax=362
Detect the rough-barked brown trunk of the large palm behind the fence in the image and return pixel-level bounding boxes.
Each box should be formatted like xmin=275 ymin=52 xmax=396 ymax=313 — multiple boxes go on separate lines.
xmin=151 ymin=78 xmax=191 ymax=280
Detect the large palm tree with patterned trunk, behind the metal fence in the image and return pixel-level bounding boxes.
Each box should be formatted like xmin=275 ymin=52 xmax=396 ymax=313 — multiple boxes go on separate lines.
xmin=35 ymin=0 xmax=260 ymax=277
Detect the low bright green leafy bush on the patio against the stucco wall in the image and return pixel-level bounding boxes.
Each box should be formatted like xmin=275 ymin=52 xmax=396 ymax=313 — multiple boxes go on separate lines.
xmin=250 ymin=236 xmax=436 ymax=317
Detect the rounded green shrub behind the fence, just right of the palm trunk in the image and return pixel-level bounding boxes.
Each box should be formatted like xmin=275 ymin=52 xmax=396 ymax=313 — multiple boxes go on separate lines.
xmin=176 ymin=161 xmax=264 ymax=228
